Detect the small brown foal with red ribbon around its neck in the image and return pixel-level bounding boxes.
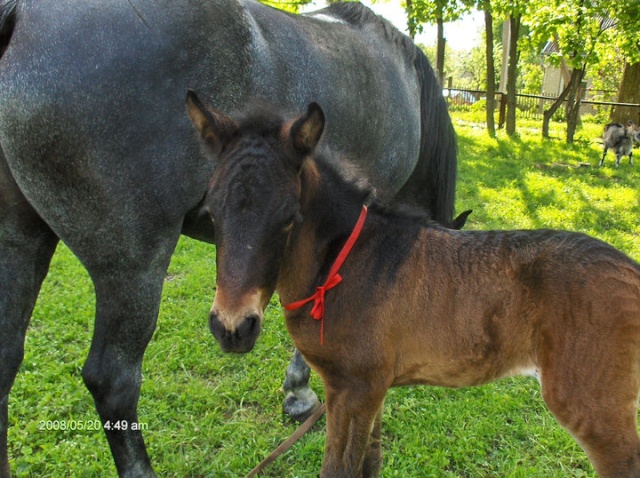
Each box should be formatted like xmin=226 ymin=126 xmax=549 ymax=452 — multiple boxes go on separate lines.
xmin=189 ymin=100 xmax=640 ymax=478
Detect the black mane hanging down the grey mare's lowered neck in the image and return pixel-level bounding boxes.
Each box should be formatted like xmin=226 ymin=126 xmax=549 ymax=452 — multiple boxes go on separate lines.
xmin=399 ymin=46 xmax=458 ymax=227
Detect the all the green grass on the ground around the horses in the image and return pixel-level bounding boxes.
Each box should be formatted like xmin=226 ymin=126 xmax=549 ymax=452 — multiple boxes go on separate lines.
xmin=9 ymin=114 xmax=640 ymax=478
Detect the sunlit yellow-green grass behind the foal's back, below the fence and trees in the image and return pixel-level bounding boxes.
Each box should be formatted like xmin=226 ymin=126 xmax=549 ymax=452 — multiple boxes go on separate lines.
xmin=454 ymin=115 xmax=640 ymax=260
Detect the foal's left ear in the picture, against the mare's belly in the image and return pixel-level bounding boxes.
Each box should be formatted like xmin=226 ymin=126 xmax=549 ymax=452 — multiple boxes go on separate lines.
xmin=187 ymin=90 xmax=238 ymax=154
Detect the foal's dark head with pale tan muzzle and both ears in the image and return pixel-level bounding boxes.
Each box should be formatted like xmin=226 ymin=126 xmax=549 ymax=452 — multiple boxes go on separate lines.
xmin=187 ymin=92 xmax=324 ymax=352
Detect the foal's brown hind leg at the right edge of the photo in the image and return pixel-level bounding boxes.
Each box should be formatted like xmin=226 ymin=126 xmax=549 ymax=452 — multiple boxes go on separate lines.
xmin=541 ymin=327 xmax=640 ymax=478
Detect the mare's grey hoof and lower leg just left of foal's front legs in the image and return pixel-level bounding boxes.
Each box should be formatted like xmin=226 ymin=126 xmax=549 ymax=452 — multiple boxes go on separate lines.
xmin=283 ymin=349 xmax=320 ymax=422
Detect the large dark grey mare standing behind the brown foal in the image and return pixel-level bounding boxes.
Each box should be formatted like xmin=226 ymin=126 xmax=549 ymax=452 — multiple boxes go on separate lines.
xmin=0 ymin=0 xmax=456 ymax=478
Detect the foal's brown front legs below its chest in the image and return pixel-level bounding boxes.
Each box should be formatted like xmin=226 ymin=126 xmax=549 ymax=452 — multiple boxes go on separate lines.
xmin=320 ymin=377 xmax=387 ymax=478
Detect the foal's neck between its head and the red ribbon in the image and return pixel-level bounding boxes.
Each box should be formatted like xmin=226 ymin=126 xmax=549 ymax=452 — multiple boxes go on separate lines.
xmin=277 ymin=161 xmax=367 ymax=303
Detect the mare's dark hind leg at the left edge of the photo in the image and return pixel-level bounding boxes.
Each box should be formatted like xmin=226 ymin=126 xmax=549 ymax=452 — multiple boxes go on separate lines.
xmin=0 ymin=158 xmax=58 ymax=478
